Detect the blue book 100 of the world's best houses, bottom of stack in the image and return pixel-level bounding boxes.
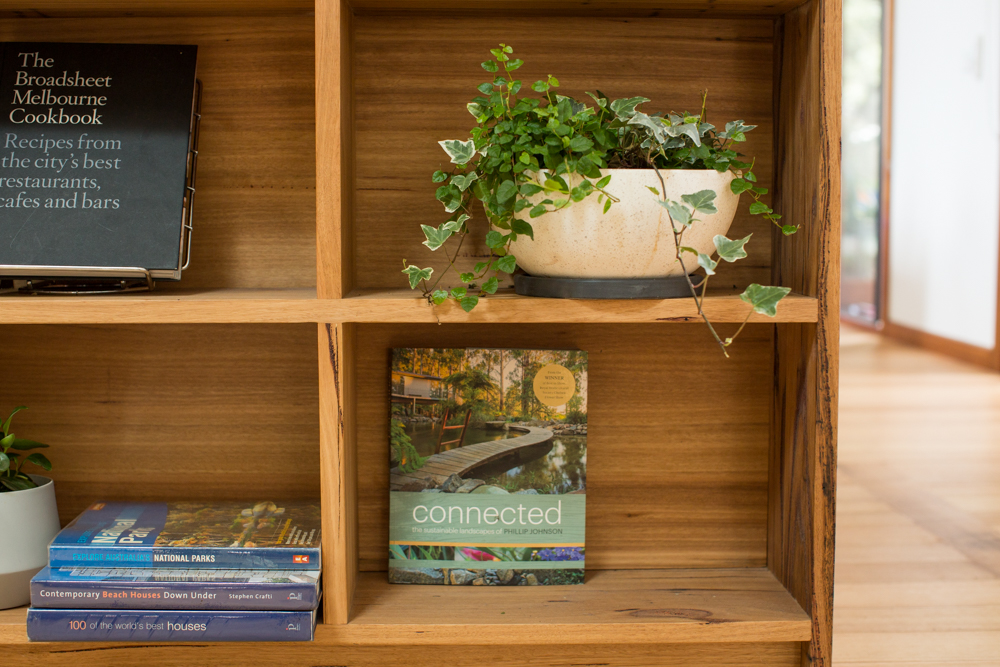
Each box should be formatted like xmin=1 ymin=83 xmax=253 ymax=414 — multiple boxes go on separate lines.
xmin=28 ymin=607 xmax=316 ymax=642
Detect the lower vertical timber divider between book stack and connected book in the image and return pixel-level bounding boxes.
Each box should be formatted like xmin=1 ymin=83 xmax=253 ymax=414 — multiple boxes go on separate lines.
xmin=319 ymin=323 xmax=358 ymax=624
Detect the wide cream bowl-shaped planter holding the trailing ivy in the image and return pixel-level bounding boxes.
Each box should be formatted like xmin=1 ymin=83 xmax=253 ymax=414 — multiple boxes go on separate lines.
xmin=511 ymin=169 xmax=740 ymax=278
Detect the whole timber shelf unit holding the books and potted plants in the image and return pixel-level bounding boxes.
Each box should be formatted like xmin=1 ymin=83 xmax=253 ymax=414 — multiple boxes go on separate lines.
xmin=0 ymin=0 xmax=841 ymax=667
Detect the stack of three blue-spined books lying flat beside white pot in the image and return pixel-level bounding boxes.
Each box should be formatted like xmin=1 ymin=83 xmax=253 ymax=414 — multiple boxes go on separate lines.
xmin=28 ymin=502 xmax=320 ymax=641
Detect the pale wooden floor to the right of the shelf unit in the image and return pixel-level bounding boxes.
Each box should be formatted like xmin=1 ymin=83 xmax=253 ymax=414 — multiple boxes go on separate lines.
xmin=833 ymin=328 xmax=1000 ymax=667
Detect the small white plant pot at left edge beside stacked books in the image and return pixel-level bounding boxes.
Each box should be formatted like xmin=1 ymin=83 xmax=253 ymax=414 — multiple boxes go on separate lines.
xmin=0 ymin=475 xmax=59 ymax=609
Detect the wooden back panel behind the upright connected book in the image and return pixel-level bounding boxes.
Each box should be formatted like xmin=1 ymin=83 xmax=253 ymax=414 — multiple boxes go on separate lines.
xmin=356 ymin=324 xmax=773 ymax=571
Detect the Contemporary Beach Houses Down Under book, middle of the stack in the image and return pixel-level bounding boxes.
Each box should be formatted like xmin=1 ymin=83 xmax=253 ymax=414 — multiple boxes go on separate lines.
xmin=31 ymin=567 xmax=319 ymax=611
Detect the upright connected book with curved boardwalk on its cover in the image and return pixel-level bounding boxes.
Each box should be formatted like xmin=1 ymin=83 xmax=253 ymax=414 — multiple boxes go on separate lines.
xmin=389 ymin=348 xmax=587 ymax=586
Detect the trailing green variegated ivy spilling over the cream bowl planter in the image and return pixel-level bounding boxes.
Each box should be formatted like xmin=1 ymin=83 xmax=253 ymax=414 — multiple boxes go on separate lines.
xmin=402 ymin=44 xmax=797 ymax=356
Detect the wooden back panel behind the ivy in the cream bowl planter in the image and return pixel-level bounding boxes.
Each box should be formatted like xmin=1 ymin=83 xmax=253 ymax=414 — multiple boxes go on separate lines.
xmin=353 ymin=14 xmax=773 ymax=290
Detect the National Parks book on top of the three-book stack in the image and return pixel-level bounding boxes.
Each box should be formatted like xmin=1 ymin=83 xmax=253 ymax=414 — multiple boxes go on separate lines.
xmin=49 ymin=501 xmax=320 ymax=570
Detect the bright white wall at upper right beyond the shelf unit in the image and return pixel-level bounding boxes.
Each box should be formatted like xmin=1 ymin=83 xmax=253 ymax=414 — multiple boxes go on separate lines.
xmin=887 ymin=0 xmax=1000 ymax=348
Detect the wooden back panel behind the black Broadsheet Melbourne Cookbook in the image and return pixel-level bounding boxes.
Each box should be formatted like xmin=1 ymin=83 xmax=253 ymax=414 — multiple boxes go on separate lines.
xmin=0 ymin=16 xmax=316 ymax=291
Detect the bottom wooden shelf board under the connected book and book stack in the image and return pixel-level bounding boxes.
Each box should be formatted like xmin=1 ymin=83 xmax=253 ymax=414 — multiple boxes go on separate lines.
xmin=0 ymin=568 xmax=812 ymax=646
